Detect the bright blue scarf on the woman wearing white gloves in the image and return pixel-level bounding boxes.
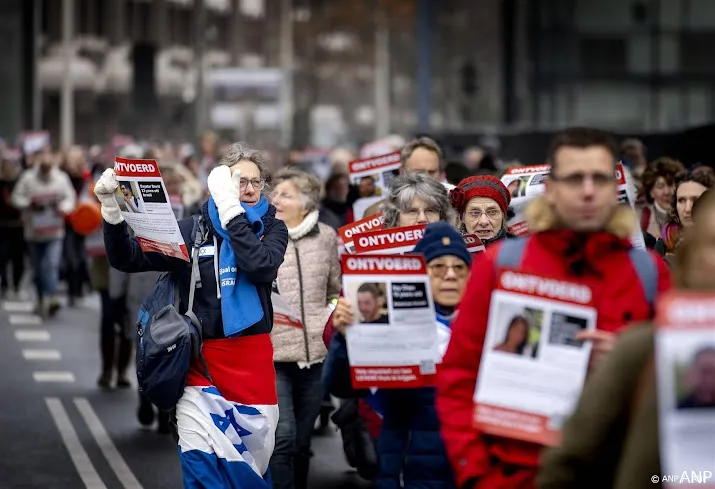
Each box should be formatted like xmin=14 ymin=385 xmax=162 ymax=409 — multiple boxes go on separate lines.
xmin=209 ymin=197 xmax=268 ymax=338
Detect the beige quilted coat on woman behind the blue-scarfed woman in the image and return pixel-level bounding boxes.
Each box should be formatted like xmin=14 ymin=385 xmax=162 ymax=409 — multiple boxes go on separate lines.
xmin=271 ymin=215 xmax=341 ymax=363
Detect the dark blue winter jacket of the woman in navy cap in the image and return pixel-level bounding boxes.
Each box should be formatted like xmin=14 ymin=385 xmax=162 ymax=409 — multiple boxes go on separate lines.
xmin=323 ymin=308 xmax=457 ymax=489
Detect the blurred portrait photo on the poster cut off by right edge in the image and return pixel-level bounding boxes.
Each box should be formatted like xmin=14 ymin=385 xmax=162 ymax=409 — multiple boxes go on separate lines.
xmin=673 ymin=342 xmax=715 ymax=411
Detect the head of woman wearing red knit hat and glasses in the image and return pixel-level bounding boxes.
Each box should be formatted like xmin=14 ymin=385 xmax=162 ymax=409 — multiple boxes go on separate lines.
xmin=449 ymin=175 xmax=514 ymax=245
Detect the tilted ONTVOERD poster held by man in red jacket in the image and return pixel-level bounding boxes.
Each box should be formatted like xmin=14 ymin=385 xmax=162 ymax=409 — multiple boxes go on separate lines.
xmin=474 ymin=270 xmax=596 ymax=445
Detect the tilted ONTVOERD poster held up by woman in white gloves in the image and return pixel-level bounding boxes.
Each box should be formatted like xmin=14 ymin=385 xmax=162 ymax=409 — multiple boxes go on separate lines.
xmin=114 ymin=156 xmax=189 ymax=261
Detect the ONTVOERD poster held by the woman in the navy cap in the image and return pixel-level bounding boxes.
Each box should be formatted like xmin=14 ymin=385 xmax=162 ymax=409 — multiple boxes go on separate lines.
xmin=342 ymin=255 xmax=439 ymax=389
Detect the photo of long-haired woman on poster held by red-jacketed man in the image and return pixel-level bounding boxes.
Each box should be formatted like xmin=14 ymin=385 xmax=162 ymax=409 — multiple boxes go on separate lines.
xmin=491 ymin=302 xmax=544 ymax=359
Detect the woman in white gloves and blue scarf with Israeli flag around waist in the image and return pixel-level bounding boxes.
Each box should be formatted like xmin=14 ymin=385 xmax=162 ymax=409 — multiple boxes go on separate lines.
xmin=94 ymin=143 xmax=288 ymax=489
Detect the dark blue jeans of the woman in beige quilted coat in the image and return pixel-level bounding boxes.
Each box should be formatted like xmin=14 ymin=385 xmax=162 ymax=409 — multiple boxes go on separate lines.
xmin=269 ymin=362 xmax=323 ymax=489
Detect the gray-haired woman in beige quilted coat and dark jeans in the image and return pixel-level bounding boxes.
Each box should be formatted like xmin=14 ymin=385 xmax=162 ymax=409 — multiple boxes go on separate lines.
xmin=270 ymin=168 xmax=340 ymax=489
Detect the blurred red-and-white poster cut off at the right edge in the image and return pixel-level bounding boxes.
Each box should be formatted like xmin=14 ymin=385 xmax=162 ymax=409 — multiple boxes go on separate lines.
xmin=655 ymin=292 xmax=715 ymax=488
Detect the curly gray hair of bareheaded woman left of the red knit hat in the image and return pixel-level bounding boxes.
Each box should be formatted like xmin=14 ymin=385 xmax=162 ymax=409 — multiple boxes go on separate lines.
xmin=381 ymin=172 xmax=459 ymax=229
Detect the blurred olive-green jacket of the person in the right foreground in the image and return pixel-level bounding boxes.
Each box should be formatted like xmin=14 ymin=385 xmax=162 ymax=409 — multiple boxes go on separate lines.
xmin=537 ymin=324 xmax=661 ymax=489
